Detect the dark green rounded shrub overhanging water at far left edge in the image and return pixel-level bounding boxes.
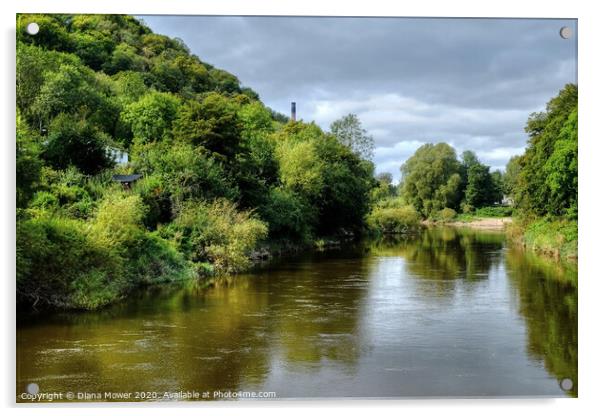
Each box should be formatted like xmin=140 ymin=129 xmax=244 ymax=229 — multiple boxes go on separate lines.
xmin=17 ymin=217 xmax=127 ymax=309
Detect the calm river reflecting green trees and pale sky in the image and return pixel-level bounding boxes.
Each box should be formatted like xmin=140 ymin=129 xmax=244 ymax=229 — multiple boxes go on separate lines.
xmin=17 ymin=228 xmax=577 ymax=401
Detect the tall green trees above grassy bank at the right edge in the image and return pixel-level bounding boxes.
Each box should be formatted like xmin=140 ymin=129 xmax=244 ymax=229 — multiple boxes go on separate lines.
xmin=496 ymin=84 xmax=578 ymax=260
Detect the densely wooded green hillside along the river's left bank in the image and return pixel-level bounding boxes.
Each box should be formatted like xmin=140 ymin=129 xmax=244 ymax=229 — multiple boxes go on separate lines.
xmin=17 ymin=15 xmax=375 ymax=308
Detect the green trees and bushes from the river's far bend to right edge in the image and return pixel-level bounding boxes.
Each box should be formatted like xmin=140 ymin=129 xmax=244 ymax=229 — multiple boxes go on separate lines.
xmin=368 ymin=84 xmax=578 ymax=259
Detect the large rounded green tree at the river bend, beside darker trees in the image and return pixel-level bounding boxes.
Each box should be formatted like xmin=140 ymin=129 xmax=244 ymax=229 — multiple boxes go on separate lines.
xmin=401 ymin=143 xmax=462 ymax=217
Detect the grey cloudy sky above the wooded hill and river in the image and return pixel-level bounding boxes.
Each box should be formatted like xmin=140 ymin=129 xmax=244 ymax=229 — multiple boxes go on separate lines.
xmin=142 ymin=16 xmax=577 ymax=179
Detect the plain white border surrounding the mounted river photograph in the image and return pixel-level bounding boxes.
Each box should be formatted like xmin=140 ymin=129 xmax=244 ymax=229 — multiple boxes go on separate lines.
xmin=0 ymin=0 xmax=602 ymax=416
